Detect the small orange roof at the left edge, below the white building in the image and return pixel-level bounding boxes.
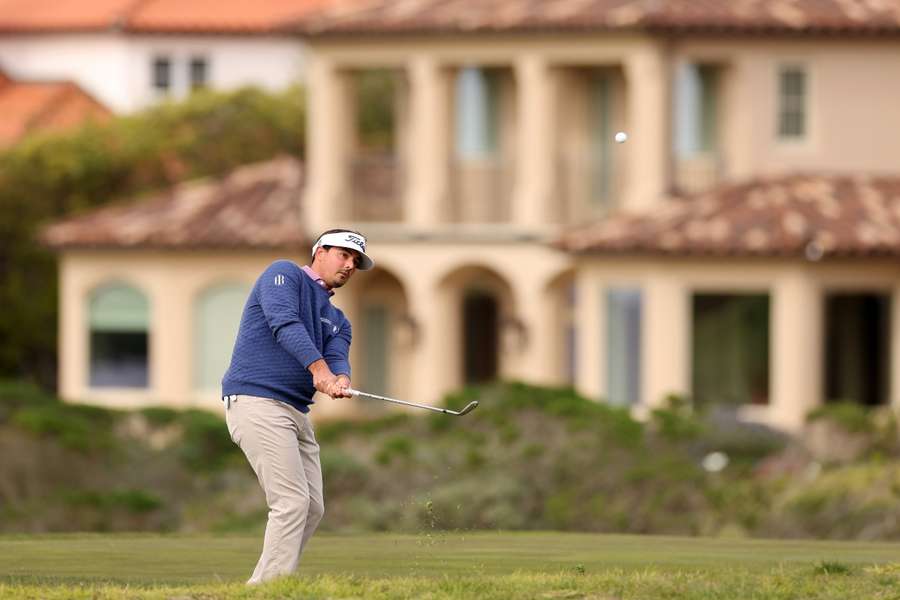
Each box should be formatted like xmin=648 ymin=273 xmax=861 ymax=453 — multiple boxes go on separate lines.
xmin=0 ymin=76 xmax=111 ymax=146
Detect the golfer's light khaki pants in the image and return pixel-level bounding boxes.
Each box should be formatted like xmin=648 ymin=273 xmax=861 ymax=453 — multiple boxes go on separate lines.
xmin=225 ymin=395 xmax=325 ymax=583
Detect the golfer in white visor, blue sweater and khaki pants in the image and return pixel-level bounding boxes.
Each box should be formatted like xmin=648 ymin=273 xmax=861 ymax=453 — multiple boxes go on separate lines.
xmin=222 ymin=229 xmax=375 ymax=584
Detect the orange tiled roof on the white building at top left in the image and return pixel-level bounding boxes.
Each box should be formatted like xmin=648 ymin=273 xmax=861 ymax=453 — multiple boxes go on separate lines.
xmin=0 ymin=0 xmax=327 ymax=33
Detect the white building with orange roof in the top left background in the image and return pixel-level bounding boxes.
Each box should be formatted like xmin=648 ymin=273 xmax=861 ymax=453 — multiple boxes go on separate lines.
xmin=0 ymin=0 xmax=324 ymax=113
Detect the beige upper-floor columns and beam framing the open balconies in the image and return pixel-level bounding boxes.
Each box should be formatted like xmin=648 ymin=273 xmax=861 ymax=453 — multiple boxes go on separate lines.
xmin=307 ymin=34 xmax=670 ymax=233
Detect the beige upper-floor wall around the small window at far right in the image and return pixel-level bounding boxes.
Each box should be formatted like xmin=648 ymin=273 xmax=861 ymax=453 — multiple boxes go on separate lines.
xmin=676 ymin=38 xmax=900 ymax=179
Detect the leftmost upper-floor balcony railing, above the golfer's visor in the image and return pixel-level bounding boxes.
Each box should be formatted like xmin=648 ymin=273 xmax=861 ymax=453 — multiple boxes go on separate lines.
xmin=348 ymin=153 xmax=404 ymax=222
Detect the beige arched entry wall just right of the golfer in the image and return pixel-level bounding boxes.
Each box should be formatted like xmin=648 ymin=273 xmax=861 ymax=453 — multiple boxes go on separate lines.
xmin=335 ymin=237 xmax=570 ymax=402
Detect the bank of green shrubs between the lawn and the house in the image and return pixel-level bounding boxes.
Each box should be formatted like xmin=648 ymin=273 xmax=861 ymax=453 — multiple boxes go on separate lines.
xmin=0 ymin=380 xmax=900 ymax=540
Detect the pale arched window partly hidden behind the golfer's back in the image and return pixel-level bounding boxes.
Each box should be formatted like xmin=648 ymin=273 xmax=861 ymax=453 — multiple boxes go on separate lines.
xmin=194 ymin=283 xmax=250 ymax=390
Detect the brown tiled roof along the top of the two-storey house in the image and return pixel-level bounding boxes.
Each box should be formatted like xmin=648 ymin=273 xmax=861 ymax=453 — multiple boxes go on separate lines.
xmin=298 ymin=0 xmax=900 ymax=35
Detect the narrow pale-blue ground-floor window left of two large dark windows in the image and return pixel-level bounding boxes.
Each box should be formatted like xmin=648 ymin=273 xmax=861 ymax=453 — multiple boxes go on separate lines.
xmin=606 ymin=288 xmax=642 ymax=406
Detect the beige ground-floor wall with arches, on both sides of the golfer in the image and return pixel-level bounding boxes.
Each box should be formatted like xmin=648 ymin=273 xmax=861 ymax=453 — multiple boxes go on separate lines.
xmin=60 ymin=239 xmax=569 ymax=417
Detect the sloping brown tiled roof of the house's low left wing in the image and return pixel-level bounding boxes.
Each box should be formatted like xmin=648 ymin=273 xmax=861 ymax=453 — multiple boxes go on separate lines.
xmin=41 ymin=157 xmax=312 ymax=250
